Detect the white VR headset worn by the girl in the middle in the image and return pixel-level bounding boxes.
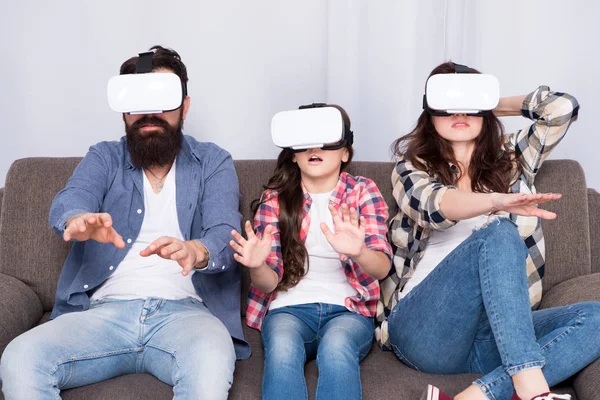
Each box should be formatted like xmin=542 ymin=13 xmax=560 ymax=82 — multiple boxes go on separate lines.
xmin=271 ymin=103 xmax=354 ymax=152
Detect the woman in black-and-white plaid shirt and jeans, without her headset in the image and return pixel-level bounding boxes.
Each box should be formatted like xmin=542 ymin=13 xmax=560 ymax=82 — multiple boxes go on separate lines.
xmin=376 ymin=63 xmax=600 ymax=400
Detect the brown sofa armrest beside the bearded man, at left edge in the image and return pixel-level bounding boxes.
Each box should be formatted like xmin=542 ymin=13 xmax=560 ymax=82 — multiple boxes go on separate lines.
xmin=0 ymin=273 xmax=43 ymax=354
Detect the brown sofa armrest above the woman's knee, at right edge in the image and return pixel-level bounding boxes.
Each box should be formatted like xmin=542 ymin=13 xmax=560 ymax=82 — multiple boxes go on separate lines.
xmin=540 ymin=272 xmax=600 ymax=308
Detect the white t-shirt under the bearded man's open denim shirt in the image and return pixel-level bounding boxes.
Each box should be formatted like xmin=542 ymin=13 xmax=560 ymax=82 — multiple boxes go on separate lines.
xmin=92 ymin=163 xmax=200 ymax=300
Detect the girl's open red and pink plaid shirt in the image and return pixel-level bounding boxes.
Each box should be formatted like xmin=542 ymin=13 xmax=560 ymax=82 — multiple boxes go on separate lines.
xmin=246 ymin=172 xmax=392 ymax=329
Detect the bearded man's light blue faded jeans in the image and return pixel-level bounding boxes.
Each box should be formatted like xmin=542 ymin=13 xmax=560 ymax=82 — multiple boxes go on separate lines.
xmin=0 ymin=298 xmax=235 ymax=400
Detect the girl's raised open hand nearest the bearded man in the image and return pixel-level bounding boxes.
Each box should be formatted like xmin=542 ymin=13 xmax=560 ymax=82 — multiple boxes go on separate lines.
xmin=229 ymin=221 xmax=273 ymax=268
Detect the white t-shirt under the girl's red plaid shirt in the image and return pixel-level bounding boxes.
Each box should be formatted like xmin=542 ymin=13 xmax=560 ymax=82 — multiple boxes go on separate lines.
xmin=269 ymin=192 xmax=357 ymax=310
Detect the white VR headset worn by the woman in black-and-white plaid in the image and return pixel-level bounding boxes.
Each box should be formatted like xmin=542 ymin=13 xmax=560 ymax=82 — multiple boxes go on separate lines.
xmin=423 ymin=64 xmax=500 ymax=116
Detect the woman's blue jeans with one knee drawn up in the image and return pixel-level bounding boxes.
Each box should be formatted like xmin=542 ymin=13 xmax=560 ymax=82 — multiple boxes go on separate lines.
xmin=388 ymin=218 xmax=600 ymax=400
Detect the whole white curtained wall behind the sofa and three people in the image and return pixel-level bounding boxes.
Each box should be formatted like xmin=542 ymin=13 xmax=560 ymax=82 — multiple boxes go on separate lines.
xmin=0 ymin=0 xmax=600 ymax=189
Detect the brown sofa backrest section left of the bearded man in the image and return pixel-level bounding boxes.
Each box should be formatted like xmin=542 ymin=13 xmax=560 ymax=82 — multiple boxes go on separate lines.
xmin=0 ymin=158 xmax=80 ymax=311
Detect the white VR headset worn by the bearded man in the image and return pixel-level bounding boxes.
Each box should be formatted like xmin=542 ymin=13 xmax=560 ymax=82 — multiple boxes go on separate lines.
xmin=107 ymin=51 xmax=187 ymax=114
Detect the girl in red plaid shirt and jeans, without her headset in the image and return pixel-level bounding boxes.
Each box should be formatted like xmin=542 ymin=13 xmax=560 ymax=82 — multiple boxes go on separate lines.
xmin=230 ymin=105 xmax=392 ymax=400
